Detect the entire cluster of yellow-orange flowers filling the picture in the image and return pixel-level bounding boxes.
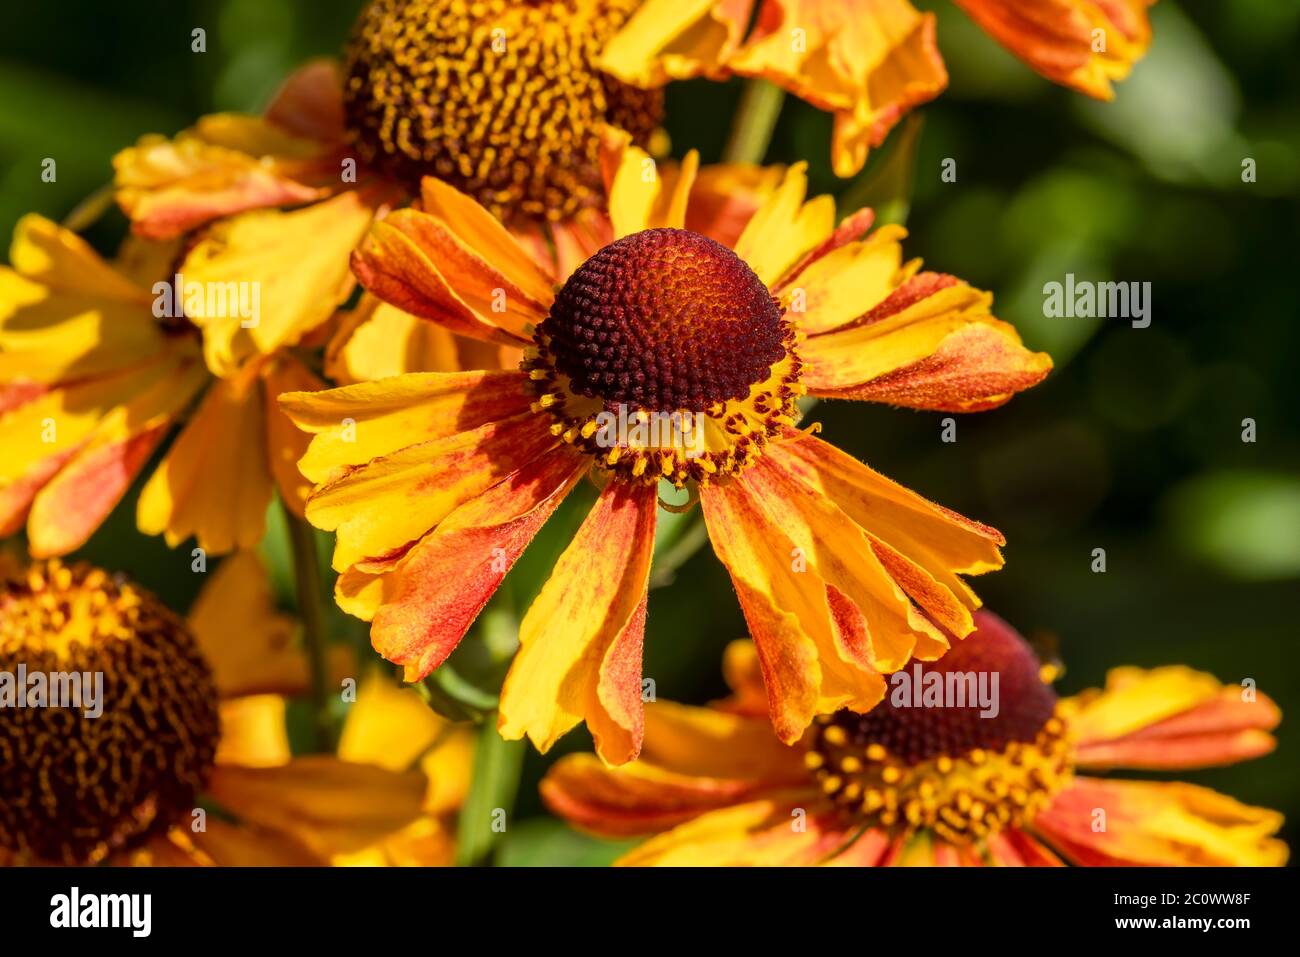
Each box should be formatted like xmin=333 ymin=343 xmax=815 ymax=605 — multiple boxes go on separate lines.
xmin=0 ymin=0 xmax=1286 ymax=866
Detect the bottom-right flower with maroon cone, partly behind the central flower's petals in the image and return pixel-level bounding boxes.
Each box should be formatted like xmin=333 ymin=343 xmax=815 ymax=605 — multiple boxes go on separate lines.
xmin=542 ymin=611 xmax=1287 ymax=867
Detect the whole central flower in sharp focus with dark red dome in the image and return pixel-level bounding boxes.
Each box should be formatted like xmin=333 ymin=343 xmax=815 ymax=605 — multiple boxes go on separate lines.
xmin=281 ymin=137 xmax=1050 ymax=762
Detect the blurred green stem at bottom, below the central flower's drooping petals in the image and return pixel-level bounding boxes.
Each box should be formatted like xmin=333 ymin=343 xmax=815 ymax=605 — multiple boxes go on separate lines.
xmin=456 ymin=711 xmax=525 ymax=867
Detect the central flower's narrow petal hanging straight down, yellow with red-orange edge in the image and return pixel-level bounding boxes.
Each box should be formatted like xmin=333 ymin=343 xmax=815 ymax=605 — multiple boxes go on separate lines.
xmin=498 ymin=481 xmax=658 ymax=765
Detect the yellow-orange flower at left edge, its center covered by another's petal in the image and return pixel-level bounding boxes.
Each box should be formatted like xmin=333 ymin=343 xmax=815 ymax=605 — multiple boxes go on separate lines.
xmin=0 ymin=216 xmax=324 ymax=558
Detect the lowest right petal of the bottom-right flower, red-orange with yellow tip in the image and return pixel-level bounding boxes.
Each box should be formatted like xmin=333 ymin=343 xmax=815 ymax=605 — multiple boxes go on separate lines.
xmin=1034 ymin=778 xmax=1287 ymax=867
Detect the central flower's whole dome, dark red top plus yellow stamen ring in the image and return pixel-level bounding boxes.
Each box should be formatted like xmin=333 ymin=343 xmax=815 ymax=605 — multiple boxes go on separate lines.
xmin=523 ymin=229 xmax=802 ymax=488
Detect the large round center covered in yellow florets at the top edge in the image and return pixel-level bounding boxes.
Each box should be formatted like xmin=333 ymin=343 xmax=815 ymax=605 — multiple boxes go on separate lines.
xmin=343 ymin=0 xmax=663 ymax=220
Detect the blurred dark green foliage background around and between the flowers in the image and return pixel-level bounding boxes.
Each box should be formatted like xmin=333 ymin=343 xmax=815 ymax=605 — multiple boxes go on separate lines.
xmin=0 ymin=0 xmax=1300 ymax=863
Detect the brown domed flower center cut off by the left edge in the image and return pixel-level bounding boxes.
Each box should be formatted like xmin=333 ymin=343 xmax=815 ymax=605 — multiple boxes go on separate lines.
xmin=0 ymin=562 xmax=218 ymax=865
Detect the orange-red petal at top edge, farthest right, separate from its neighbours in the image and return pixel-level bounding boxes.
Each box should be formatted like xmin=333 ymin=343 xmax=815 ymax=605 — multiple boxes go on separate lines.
xmin=957 ymin=0 xmax=1154 ymax=100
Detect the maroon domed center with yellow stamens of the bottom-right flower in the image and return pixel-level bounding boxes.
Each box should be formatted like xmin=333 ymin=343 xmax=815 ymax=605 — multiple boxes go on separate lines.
xmin=805 ymin=631 xmax=1073 ymax=844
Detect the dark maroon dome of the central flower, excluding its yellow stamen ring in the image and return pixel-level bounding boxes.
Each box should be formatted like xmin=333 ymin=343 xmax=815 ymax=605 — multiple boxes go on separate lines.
xmin=538 ymin=229 xmax=787 ymax=412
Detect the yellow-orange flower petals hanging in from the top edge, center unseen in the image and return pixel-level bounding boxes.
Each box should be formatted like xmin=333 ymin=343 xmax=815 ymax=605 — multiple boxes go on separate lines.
xmin=601 ymin=0 xmax=1154 ymax=177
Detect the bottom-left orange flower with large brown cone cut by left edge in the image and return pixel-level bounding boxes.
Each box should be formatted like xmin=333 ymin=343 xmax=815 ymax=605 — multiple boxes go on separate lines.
xmin=0 ymin=553 xmax=468 ymax=866
